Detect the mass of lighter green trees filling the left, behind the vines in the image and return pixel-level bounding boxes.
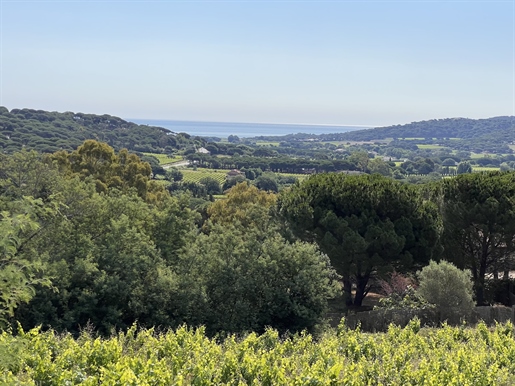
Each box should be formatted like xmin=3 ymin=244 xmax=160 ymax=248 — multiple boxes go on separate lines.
xmin=0 ymin=145 xmax=338 ymax=335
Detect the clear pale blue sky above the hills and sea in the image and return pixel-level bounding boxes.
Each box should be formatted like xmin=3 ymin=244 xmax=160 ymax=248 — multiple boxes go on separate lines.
xmin=0 ymin=0 xmax=515 ymax=126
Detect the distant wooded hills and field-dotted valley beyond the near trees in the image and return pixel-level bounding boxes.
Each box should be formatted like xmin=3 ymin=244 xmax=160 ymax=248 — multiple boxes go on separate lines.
xmin=0 ymin=108 xmax=515 ymax=189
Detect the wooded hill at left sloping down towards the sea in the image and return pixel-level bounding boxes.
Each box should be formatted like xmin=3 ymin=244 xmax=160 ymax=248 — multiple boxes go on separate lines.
xmin=0 ymin=106 xmax=187 ymax=153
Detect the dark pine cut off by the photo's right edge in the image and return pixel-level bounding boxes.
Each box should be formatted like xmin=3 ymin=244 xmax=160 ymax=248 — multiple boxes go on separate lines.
xmin=440 ymin=172 xmax=515 ymax=305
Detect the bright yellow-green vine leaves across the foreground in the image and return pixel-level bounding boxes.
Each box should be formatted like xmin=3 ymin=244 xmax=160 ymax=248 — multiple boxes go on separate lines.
xmin=0 ymin=320 xmax=515 ymax=386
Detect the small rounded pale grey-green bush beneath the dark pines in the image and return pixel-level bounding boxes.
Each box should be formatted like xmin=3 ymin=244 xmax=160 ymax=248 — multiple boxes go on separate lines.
xmin=417 ymin=261 xmax=474 ymax=318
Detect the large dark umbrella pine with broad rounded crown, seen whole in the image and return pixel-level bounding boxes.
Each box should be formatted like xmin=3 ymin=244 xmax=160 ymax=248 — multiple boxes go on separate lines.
xmin=279 ymin=173 xmax=439 ymax=306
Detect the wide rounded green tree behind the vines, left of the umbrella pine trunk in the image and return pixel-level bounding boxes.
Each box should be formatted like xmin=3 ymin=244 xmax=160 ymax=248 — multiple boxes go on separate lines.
xmin=178 ymin=223 xmax=339 ymax=335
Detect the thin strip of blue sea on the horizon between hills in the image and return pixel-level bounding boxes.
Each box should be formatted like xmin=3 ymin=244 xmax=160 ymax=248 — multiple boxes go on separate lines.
xmin=127 ymin=119 xmax=372 ymax=138
